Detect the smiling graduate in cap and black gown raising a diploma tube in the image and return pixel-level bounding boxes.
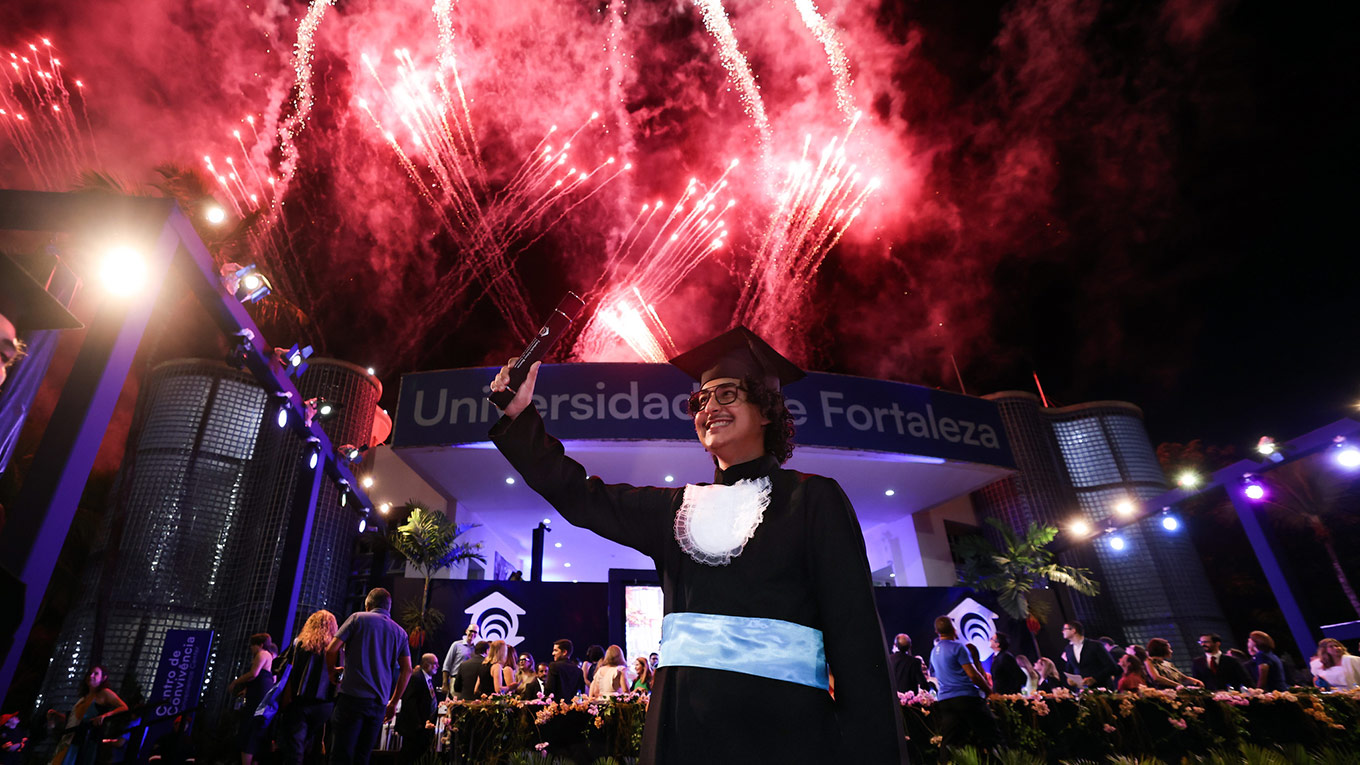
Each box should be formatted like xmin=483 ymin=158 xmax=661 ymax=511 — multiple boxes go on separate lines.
xmin=491 ymin=327 xmax=907 ymax=765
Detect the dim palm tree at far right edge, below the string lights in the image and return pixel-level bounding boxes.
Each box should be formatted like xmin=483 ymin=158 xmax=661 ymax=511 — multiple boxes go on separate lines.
xmin=1262 ymin=455 xmax=1360 ymax=618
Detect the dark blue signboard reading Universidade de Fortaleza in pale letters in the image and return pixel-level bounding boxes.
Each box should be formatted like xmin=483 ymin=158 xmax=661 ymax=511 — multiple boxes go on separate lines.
xmin=393 ymin=363 xmax=1015 ymax=467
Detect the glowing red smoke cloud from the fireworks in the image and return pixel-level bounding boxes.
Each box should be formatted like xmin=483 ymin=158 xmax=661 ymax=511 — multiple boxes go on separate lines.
xmin=0 ymin=0 xmax=1234 ymax=389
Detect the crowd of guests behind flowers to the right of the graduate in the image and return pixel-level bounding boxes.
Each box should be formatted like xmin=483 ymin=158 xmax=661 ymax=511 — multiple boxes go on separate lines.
xmin=889 ymin=617 xmax=1360 ymax=749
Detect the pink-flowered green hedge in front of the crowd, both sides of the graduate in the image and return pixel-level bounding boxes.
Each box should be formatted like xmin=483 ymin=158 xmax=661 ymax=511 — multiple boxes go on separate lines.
xmin=445 ymin=689 xmax=1360 ymax=764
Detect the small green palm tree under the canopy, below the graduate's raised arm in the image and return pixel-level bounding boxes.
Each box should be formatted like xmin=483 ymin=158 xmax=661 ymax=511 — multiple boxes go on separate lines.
xmin=392 ymin=500 xmax=487 ymax=648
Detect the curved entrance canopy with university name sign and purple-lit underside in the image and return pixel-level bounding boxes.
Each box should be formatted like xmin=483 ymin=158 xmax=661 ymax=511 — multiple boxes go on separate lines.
xmin=393 ymin=363 xmax=1015 ymax=577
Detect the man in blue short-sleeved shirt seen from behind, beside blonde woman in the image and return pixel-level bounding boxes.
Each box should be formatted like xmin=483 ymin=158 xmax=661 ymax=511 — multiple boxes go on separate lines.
xmin=326 ymin=587 xmax=411 ymax=765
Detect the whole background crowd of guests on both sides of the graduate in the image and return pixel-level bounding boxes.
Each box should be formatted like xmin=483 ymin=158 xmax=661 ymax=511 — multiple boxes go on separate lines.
xmin=13 ymin=588 xmax=1360 ymax=765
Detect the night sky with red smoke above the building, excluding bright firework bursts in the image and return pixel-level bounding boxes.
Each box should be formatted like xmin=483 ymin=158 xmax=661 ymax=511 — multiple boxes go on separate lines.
xmin=0 ymin=0 xmax=1360 ymax=451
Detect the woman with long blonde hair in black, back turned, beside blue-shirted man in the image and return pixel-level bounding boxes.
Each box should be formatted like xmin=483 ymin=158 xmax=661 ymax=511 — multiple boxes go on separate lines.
xmin=277 ymin=608 xmax=344 ymax=764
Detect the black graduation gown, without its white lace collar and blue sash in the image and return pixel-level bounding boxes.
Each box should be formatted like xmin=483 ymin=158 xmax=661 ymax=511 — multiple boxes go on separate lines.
xmin=491 ymin=407 xmax=907 ymax=765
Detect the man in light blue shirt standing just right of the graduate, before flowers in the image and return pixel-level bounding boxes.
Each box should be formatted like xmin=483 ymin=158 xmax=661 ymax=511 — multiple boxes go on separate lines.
xmin=930 ymin=617 xmax=1001 ymax=750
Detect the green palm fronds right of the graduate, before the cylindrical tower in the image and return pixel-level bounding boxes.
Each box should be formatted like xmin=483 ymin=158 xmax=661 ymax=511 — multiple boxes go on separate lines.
xmin=959 ymin=519 xmax=1100 ymax=622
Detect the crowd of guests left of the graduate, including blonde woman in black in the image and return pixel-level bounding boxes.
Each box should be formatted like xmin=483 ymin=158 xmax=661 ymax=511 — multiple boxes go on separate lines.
xmin=217 ymin=588 xmax=658 ymax=765
